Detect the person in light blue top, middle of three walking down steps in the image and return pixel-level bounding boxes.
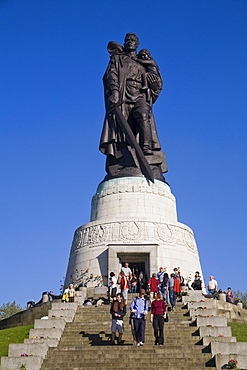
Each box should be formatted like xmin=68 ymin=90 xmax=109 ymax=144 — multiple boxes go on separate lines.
xmin=130 ymin=289 xmax=148 ymax=346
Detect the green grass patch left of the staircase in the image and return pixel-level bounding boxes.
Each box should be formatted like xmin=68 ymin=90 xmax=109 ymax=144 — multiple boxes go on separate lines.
xmin=0 ymin=325 xmax=33 ymax=357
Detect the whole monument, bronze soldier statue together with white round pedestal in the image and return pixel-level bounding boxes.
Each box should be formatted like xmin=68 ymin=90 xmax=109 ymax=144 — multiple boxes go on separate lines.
xmin=65 ymin=33 xmax=204 ymax=287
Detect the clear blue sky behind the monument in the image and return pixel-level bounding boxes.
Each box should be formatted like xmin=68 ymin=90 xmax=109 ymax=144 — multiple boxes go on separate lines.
xmin=0 ymin=0 xmax=247 ymax=305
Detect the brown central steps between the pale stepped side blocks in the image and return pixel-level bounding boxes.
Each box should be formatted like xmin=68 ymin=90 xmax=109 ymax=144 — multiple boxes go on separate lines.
xmin=38 ymin=292 xmax=215 ymax=370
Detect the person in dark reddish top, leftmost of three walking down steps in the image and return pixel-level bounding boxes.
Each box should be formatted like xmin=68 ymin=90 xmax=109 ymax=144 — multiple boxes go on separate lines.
xmin=110 ymin=293 xmax=126 ymax=344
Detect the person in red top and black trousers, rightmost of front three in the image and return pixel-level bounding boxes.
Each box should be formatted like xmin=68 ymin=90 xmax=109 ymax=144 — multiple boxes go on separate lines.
xmin=150 ymin=292 xmax=166 ymax=346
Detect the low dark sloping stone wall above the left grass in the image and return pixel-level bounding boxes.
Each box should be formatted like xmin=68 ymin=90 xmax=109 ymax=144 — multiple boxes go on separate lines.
xmin=0 ymin=302 xmax=52 ymax=330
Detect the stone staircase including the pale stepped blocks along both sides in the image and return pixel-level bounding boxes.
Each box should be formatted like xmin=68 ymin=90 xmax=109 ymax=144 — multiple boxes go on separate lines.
xmin=1 ymin=291 xmax=247 ymax=370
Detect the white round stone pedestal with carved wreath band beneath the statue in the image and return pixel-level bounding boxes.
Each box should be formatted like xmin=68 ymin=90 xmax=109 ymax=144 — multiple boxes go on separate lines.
xmin=65 ymin=177 xmax=204 ymax=286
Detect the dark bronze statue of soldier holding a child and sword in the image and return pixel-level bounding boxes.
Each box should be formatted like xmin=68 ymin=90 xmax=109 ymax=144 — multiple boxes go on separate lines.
xmin=100 ymin=33 xmax=167 ymax=181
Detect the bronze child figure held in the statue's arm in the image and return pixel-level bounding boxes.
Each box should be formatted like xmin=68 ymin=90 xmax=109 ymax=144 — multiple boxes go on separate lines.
xmin=137 ymin=49 xmax=159 ymax=101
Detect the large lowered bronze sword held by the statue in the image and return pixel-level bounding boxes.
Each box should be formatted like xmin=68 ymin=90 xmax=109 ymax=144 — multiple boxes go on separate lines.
xmin=112 ymin=106 xmax=154 ymax=183
